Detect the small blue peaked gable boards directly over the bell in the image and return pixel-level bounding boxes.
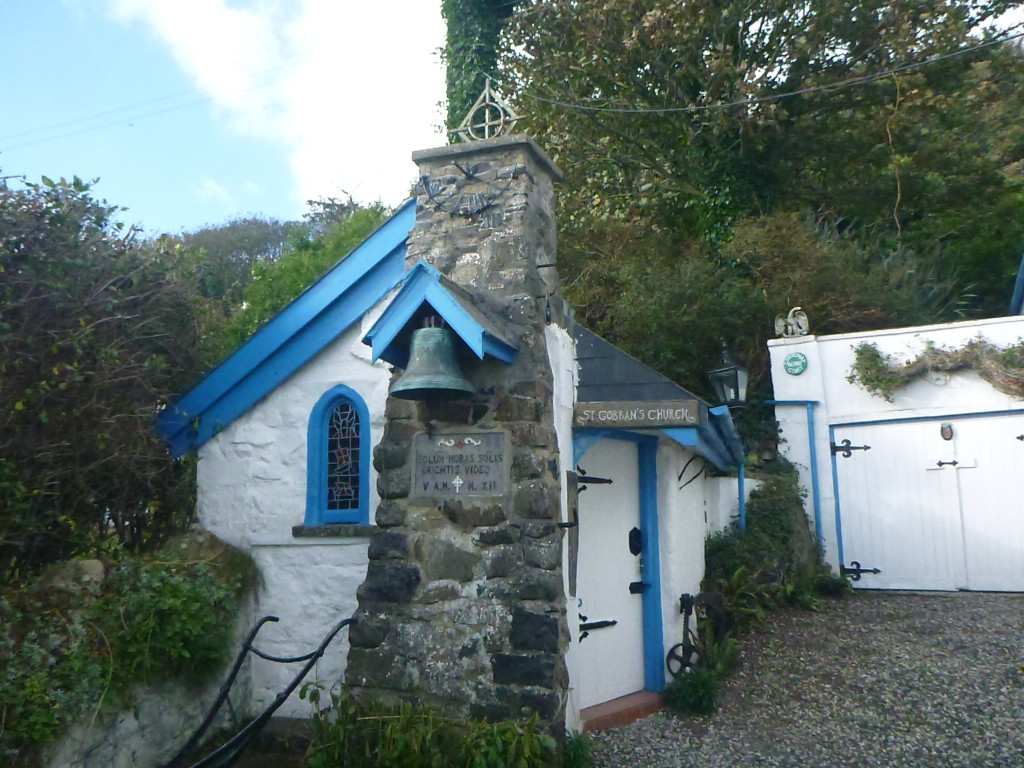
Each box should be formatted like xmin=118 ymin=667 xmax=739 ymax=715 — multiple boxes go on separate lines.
xmin=362 ymin=261 xmax=516 ymax=368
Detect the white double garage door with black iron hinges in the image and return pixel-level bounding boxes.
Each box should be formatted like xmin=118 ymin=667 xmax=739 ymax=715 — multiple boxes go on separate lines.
xmin=834 ymin=415 xmax=1024 ymax=592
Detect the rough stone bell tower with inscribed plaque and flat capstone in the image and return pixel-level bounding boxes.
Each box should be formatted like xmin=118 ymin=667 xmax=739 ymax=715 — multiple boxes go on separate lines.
xmin=346 ymin=135 xmax=573 ymax=732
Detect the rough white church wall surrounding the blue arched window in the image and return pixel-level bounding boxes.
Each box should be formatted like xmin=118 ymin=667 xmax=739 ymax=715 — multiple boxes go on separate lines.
xmin=198 ymin=313 xmax=390 ymax=717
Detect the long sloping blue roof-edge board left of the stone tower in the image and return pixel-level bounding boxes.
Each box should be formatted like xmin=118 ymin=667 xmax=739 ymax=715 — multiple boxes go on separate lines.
xmin=157 ymin=200 xmax=416 ymax=457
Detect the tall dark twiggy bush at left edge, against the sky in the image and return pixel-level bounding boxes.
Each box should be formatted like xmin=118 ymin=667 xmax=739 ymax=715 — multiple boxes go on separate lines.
xmin=0 ymin=178 xmax=205 ymax=575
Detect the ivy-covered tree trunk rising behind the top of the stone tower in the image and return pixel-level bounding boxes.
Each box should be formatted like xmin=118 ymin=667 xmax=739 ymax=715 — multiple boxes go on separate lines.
xmin=441 ymin=0 xmax=519 ymax=130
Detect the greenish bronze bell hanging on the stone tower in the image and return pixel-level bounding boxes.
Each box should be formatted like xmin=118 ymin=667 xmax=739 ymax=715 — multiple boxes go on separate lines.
xmin=391 ymin=328 xmax=476 ymax=400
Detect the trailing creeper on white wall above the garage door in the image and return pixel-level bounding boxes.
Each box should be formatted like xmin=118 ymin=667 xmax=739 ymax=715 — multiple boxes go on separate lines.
xmin=846 ymin=338 xmax=1024 ymax=402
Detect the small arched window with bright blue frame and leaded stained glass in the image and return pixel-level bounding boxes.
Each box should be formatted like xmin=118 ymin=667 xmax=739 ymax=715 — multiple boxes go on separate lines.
xmin=305 ymin=385 xmax=371 ymax=525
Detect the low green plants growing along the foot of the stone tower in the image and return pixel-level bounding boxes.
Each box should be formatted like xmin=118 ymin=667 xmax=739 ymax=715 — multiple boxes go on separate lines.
xmin=302 ymin=685 xmax=561 ymax=768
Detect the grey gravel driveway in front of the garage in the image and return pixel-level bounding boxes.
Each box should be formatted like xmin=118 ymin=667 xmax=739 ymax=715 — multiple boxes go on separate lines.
xmin=594 ymin=592 xmax=1024 ymax=768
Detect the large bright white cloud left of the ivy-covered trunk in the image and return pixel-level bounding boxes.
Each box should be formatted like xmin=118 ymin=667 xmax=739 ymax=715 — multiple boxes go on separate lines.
xmin=109 ymin=0 xmax=444 ymax=210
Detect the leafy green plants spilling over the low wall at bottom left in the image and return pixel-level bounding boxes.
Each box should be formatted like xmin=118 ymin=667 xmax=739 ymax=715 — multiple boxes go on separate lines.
xmin=0 ymin=538 xmax=253 ymax=765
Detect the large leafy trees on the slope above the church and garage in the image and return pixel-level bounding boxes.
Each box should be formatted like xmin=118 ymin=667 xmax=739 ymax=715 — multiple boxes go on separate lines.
xmin=503 ymin=0 xmax=1024 ymax=393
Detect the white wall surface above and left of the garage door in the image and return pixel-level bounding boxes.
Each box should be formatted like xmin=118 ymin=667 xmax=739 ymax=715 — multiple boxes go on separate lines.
xmin=768 ymin=316 xmax=1024 ymax=570
